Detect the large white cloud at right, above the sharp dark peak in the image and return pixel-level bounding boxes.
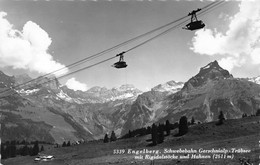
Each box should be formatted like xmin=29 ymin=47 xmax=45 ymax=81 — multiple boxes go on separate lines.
xmin=190 ymin=1 xmax=260 ymax=69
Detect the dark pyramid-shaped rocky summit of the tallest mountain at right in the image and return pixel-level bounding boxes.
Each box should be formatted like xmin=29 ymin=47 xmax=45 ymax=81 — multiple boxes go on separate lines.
xmin=184 ymin=60 xmax=233 ymax=87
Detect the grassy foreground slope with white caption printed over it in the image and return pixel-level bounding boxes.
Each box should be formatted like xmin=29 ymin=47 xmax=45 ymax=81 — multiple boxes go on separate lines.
xmin=3 ymin=116 xmax=260 ymax=165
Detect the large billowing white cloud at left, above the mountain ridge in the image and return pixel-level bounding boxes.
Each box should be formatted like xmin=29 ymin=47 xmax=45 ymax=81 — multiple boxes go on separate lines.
xmin=0 ymin=12 xmax=68 ymax=75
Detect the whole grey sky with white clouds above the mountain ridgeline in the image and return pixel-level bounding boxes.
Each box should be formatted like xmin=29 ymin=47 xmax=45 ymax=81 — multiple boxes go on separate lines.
xmin=0 ymin=0 xmax=260 ymax=91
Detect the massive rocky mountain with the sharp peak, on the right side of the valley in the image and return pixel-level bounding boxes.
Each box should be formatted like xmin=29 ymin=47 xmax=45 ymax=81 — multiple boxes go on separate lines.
xmin=119 ymin=61 xmax=260 ymax=134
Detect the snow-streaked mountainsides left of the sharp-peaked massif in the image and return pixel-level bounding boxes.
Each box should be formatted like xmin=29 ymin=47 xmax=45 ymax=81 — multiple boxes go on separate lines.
xmin=0 ymin=72 xmax=144 ymax=143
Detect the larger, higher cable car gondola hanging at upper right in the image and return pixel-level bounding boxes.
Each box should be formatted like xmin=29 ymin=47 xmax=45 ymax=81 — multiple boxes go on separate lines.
xmin=183 ymin=9 xmax=205 ymax=31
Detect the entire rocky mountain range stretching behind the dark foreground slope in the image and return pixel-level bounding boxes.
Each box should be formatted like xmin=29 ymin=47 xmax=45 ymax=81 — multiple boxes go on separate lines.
xmin=0 ymin=61 xmax=260 ymax=143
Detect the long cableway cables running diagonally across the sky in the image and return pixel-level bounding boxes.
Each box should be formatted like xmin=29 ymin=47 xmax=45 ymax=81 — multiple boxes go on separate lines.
xmin=0 ymin=1 xmax=226 ymax=97
